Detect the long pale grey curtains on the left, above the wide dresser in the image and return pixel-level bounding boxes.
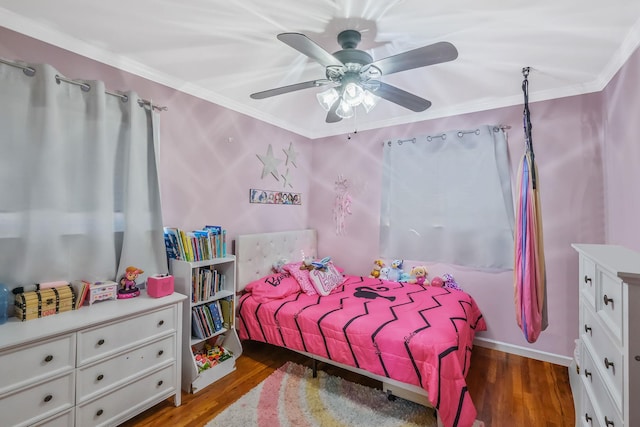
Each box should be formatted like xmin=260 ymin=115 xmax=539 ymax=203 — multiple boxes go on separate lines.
xmin=0 ymin=64 xmax=167 ymax=287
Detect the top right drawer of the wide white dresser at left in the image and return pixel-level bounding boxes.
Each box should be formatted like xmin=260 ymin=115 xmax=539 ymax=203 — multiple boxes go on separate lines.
xmin=78 ymin=306 xmax=177 ymax=366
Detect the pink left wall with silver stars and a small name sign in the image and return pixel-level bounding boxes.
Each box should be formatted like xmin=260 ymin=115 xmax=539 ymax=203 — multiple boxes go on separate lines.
xmin=0 ymin=27 xmax=311 ymax=239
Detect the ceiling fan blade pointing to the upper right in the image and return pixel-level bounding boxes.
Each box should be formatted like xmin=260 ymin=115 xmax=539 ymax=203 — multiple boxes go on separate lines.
xmin=371 ymin=42 xmax=458 ymax=75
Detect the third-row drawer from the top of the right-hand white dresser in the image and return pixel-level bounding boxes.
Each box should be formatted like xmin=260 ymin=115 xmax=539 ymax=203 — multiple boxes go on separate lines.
xmin=582 ymin=346 xmax=622 ymax=427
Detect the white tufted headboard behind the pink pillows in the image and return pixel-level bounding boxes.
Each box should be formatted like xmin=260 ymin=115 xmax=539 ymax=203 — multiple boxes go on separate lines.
xmin=235 ymin=229 xmax=318 ymax=291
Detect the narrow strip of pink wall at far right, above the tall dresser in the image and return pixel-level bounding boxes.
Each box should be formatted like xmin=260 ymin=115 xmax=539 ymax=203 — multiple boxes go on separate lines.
xmin=603 ymin=44 xmax=640 ymax=251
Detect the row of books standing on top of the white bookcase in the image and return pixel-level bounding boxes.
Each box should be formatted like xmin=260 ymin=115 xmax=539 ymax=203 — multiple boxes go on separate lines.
xmin=164 ymin=225 xmax=227 ymax=262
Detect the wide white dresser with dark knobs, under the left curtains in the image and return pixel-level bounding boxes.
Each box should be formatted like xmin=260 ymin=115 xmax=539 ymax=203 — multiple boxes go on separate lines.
xmin=0 ymin=290 xmax=186 ymax=427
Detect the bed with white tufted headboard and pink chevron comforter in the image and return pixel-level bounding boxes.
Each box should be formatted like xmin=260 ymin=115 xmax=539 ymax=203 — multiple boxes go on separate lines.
xmin=235 ymin=230 xmax=486 ymax=427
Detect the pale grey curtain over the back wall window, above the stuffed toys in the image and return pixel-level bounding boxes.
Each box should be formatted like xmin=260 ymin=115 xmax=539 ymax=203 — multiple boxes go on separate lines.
xmin=380 ymin=125 xmax=514 ymax=270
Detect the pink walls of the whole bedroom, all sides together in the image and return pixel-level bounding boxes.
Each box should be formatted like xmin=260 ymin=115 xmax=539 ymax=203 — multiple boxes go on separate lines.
xmin=0 ymin=28 xmax=640 ymax=362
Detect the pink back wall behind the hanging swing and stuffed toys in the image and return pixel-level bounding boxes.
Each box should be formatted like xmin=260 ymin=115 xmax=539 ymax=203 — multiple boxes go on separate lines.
xmin=309 ymin=94 xmax=605 ymax=362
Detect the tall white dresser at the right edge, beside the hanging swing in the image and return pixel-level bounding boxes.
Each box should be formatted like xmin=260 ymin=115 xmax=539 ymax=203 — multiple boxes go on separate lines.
xmin=572 ymin=244 xmax=640 ymax=427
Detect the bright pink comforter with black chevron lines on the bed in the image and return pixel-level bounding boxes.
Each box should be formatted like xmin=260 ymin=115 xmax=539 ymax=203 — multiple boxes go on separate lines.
xmin=237 ymin=276 xmax=486 ymax=427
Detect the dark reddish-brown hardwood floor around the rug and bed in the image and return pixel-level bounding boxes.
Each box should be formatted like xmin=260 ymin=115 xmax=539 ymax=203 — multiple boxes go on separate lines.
xmin=122 ymin=342 xmax=575 ymax=427
